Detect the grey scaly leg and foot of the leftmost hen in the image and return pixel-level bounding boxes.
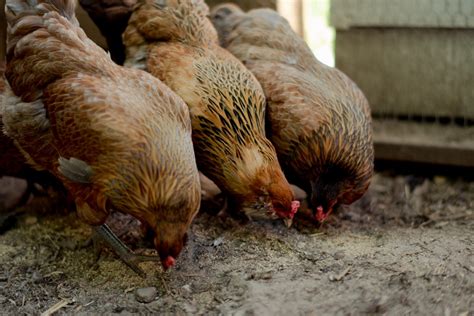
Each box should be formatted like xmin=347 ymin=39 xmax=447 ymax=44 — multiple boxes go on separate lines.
xmin=94 ymin=224 xmax=160 ymax=278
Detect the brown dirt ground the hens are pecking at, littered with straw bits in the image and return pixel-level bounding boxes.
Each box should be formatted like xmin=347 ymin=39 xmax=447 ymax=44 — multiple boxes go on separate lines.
xmin=0 ymin=172 xmax=474 ymax=315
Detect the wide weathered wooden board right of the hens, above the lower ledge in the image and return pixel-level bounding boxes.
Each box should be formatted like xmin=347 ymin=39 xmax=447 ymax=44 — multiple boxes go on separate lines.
xmin=336 ymin=29 xmax=474 ymax=119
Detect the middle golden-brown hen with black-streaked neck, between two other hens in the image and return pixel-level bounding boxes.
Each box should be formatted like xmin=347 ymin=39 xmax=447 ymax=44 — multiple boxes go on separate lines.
xmin=83 ymin=0 xmax=299 ymax=218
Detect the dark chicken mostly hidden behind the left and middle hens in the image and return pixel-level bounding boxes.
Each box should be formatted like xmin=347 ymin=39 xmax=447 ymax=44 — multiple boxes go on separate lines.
xmin=79 ymin=0 xmax=137 ymax=65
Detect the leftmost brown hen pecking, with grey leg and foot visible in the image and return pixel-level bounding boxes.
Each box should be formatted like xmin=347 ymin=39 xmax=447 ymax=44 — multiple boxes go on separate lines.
xmin=3 ymin=0 xmax=200 ymax=274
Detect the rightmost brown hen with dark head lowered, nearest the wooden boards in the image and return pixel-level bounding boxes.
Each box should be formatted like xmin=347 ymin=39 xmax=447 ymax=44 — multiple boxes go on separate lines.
xmin=211 ymin=4 xmax=374 ymax=222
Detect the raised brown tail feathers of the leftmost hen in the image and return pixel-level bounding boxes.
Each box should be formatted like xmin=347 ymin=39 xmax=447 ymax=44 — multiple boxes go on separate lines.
xmin=5 ymin=0 xmax=110 ymax=102
